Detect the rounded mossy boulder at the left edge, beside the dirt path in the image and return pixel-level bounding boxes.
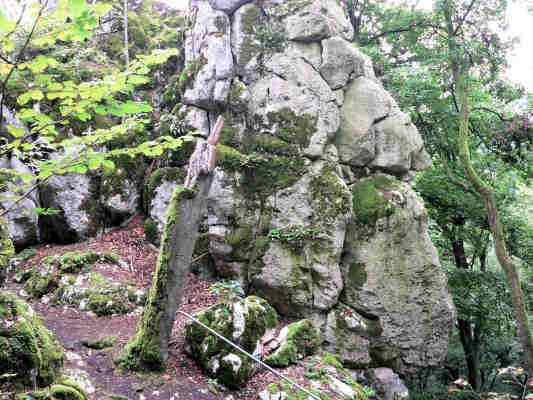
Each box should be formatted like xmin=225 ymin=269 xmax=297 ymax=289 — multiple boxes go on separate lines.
xmin=0 ymin=292 xmax=63 ymax=386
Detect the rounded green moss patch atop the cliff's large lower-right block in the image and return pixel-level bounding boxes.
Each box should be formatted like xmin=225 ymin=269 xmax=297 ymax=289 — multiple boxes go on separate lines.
xmin=352 ymin=176 xmax=397 ymax=226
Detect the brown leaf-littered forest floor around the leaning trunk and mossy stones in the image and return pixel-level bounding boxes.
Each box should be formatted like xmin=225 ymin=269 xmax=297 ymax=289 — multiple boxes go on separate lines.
xmin=2 ymin=218 xmax=304 ymax=400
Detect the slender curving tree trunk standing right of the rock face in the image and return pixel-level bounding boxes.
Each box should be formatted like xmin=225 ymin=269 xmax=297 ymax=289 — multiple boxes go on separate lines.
xmin=444 ymin=0 xmax=533 ymax=377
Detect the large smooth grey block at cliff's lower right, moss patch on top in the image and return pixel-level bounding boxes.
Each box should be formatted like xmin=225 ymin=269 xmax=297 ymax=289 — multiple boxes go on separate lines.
xmin=341 ymin=175 xmax=454 ymax=372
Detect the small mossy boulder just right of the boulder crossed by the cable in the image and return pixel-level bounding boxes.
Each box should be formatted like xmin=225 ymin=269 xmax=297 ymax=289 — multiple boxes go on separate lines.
xmin=265 ymin=319 xmax=320 ymax=367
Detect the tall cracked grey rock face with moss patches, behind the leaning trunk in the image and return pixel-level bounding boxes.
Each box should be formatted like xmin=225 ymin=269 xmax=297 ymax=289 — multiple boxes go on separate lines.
xmin=168 ymin=0 xmax=454 ymax=373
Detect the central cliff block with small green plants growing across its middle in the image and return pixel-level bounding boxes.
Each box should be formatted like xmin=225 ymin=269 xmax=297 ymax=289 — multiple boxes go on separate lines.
xmin=249 ymin=162 xmax=351 ymax=316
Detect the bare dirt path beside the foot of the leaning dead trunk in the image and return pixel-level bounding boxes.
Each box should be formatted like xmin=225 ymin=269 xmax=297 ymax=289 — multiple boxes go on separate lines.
xmin=34 ymin=303 xmax=221 ymax=400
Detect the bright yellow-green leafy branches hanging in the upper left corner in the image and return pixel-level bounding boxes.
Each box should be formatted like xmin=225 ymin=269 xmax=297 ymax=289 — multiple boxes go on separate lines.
xmin=0 ymin=1 xmax=185 ymax=205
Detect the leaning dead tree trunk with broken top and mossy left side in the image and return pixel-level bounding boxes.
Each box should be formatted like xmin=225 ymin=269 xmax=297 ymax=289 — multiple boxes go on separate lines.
xmin=118 ymin=117 xmax=224 ymax=370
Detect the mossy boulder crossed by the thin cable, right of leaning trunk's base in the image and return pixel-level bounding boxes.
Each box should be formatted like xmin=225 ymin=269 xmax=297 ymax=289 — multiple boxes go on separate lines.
xmin=185 ymin=296 xmax=278 ymax=388
